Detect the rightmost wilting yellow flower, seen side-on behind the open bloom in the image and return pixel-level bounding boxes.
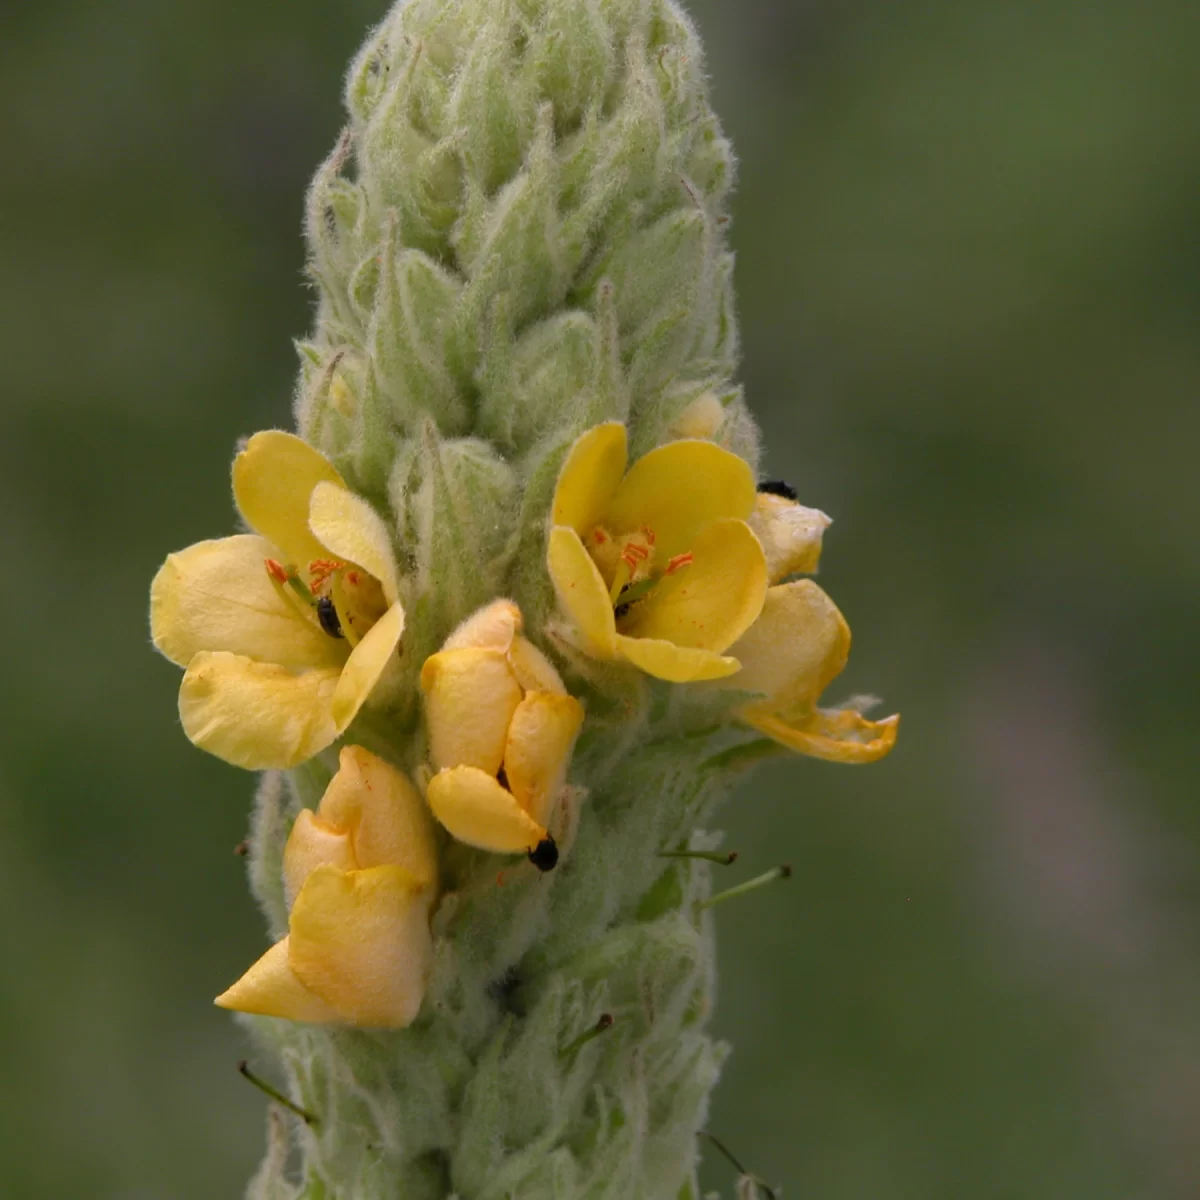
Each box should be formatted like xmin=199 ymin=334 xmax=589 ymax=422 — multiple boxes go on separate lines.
xmin=727 ymin=484 xmax=900 ymax=762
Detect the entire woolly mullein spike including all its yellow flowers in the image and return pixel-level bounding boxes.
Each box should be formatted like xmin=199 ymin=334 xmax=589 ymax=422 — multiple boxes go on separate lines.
xmin=151 ymin=0 xmax=894 ymax=1200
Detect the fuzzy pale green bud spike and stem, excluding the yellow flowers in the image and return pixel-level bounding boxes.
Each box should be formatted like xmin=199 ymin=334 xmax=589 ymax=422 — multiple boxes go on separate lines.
xmin=274 ymin=7 xmax=756 ymax=1200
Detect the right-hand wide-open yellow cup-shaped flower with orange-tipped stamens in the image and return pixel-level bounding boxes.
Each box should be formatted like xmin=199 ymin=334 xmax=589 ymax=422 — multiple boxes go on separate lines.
xmin=547 ymin=422 xmax=767 ymax=683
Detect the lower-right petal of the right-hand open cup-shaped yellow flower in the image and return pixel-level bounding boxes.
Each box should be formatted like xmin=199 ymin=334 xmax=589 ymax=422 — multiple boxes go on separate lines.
xmin=619 ymin=518 xmax=767 ymax=653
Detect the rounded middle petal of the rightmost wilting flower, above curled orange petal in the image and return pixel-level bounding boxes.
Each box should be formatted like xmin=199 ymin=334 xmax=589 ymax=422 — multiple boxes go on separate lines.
xmin=730 ymin=580 xmax=850 ymax=709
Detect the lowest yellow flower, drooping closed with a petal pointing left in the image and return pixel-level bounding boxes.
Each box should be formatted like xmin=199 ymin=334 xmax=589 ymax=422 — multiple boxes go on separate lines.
xmin=216 ymin=746 xmax=437 ymax=1028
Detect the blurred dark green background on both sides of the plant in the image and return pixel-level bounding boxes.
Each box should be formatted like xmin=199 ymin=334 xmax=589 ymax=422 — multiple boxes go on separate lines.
xmin=0 ymin=0 xmax=1200 ymax=1200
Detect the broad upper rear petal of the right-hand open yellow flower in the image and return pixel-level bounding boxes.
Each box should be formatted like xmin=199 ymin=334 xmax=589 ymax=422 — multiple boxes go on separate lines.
xmin=605 ymin=439 xmax=756 ymax=562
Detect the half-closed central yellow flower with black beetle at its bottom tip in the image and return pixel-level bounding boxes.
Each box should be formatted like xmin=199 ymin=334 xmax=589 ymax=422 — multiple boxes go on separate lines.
xmin=421 ymin=600 xmax=583 ymax=871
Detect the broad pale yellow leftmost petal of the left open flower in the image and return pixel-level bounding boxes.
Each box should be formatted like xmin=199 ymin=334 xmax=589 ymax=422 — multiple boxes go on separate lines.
xmin=150 ymin=534 xmax=346 ymax=667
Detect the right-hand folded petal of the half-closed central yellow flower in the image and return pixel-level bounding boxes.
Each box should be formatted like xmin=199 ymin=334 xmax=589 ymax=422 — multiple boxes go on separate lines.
xmin=504 ymin=691 xmax=583 ymax=827
